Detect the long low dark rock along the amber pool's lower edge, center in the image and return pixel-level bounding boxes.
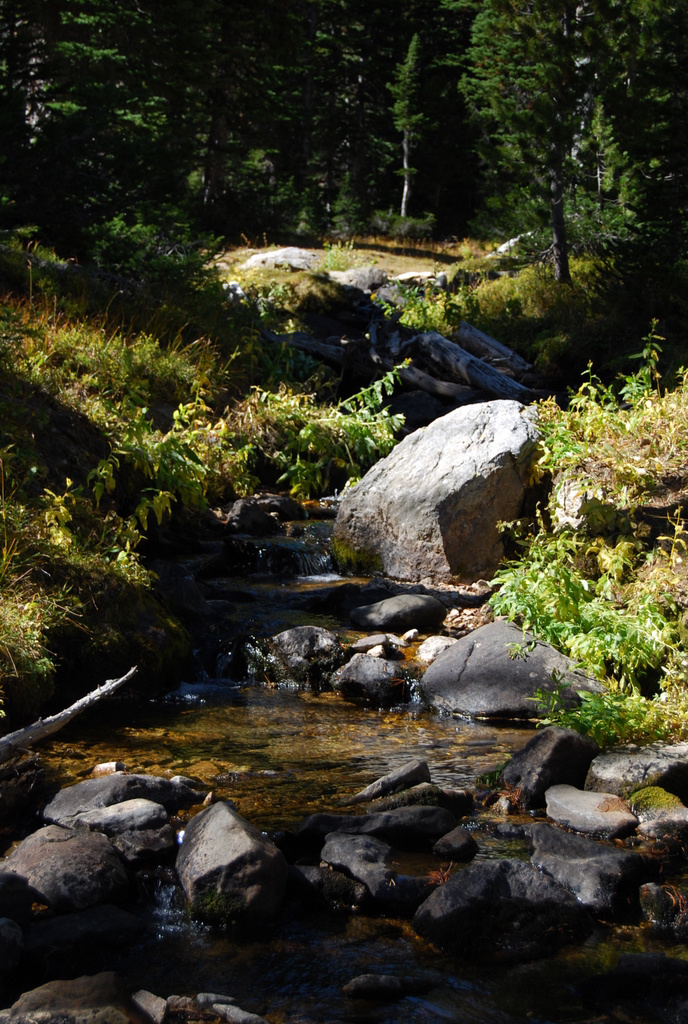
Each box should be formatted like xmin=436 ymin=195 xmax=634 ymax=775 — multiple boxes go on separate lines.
xmin=297 ymin=806 xmax=457 ymax=850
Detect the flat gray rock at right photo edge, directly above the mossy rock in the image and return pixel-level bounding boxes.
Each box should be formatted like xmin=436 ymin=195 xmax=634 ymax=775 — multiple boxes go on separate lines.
xmin=586 ymin=743 xmax=688 ymax=804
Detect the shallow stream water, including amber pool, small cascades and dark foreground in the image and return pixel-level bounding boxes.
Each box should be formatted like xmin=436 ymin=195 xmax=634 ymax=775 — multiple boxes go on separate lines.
xmin=14 ymin=516 xmax=685 ymax=1024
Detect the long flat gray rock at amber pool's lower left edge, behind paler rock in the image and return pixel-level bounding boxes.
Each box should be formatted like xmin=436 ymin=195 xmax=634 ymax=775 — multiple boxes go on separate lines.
xmin=43 ymin=772 xmax=204 ymax=826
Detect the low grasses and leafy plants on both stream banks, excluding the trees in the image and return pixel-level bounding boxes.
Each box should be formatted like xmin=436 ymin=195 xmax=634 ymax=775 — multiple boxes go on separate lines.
xmin=0 ymin=238 xmax=688 ymax=741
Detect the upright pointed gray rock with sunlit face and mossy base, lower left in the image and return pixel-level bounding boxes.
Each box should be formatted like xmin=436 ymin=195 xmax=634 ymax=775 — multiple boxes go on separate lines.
xmin=177 ymin=802 xmax=287 ymax=924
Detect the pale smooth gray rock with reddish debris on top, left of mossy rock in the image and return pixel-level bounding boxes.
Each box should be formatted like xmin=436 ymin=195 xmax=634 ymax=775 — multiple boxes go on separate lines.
xmin=545 ymin=785 xmax=638 ymax=839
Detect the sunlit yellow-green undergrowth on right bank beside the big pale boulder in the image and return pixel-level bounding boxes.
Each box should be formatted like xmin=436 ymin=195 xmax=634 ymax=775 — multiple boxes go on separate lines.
xmin=491 ymin=325 xmax=688 ymax=743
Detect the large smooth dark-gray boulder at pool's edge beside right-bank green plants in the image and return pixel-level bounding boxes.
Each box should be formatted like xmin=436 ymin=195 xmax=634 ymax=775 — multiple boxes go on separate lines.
xmin=419 ymin=621 xmax=602 ymax=719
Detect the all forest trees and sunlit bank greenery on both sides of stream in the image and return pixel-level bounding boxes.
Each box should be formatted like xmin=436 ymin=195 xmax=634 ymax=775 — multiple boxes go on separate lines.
xmin=0 ymin=0 xmax=688 ymax=738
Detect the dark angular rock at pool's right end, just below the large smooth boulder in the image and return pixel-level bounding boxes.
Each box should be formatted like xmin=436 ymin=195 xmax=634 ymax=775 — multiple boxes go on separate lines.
xmin=502 ymin=725 xmax=600 ymax=810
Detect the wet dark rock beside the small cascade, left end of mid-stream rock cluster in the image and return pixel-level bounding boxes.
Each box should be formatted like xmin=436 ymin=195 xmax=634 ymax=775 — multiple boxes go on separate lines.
xmin=268 ymin=626 xmax=346 ymax=687
